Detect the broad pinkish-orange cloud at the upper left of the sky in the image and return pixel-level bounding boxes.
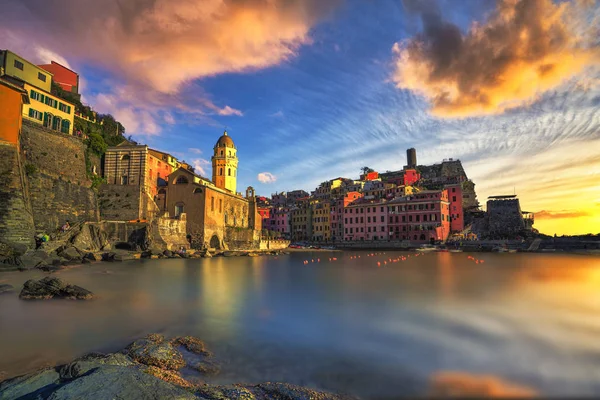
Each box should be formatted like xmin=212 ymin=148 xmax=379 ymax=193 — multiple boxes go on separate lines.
xmin=5 ymin=0 xmax=336 ymax=93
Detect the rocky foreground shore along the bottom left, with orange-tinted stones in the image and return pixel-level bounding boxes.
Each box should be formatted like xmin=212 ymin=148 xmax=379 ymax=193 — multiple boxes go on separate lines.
xmin=0 ymin=334 xmax=350 ymax=400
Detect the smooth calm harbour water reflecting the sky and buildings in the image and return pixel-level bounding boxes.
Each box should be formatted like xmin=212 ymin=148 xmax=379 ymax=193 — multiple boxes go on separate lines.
xmin=0 ymin=252 xmax=600 ymax=398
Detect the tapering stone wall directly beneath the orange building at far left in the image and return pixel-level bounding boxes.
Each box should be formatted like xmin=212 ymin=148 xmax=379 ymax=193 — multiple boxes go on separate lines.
xmin=0 ymin=141 xmax=35 ymax=247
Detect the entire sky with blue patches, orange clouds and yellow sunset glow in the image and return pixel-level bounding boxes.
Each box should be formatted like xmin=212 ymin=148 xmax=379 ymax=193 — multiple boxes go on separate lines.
xmin=0 ymin=0 xmax=600 ymax=235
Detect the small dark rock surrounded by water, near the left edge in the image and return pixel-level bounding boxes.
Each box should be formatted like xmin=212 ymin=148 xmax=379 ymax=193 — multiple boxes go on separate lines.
xmin=19 ymin=276 xmax=93 ymax=300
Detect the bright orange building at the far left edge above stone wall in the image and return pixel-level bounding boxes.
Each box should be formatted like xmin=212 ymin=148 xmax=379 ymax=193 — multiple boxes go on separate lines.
xmin=0 ymin=78 xmax=29 ymax=145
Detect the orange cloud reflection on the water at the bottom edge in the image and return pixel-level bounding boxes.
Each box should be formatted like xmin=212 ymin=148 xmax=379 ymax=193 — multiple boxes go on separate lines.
xmin=429 ymin=372 xmax=536 ymax=398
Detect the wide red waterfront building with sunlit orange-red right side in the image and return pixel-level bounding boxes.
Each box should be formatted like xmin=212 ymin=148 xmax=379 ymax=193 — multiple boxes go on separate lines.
xmin=387 ymin=189 xmax=450 ymax=242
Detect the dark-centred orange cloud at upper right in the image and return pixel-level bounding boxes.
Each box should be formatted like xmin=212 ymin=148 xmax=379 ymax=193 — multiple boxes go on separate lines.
xmin=392 ymin=0 xmax=598 ymax=117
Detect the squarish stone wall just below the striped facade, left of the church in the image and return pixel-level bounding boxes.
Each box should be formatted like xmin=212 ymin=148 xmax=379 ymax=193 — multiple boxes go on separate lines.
xmin=98 ymin=185 xmax=142 ymax=221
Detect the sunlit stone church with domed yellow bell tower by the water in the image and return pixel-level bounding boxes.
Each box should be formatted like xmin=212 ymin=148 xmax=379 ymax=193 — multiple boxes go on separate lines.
xmin=162 ymin=131 xmax=262 ymax=249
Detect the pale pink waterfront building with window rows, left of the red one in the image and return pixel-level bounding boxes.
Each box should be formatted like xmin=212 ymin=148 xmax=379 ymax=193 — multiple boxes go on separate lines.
xmin=344 ymin=199 xmax=388 ymax=240
